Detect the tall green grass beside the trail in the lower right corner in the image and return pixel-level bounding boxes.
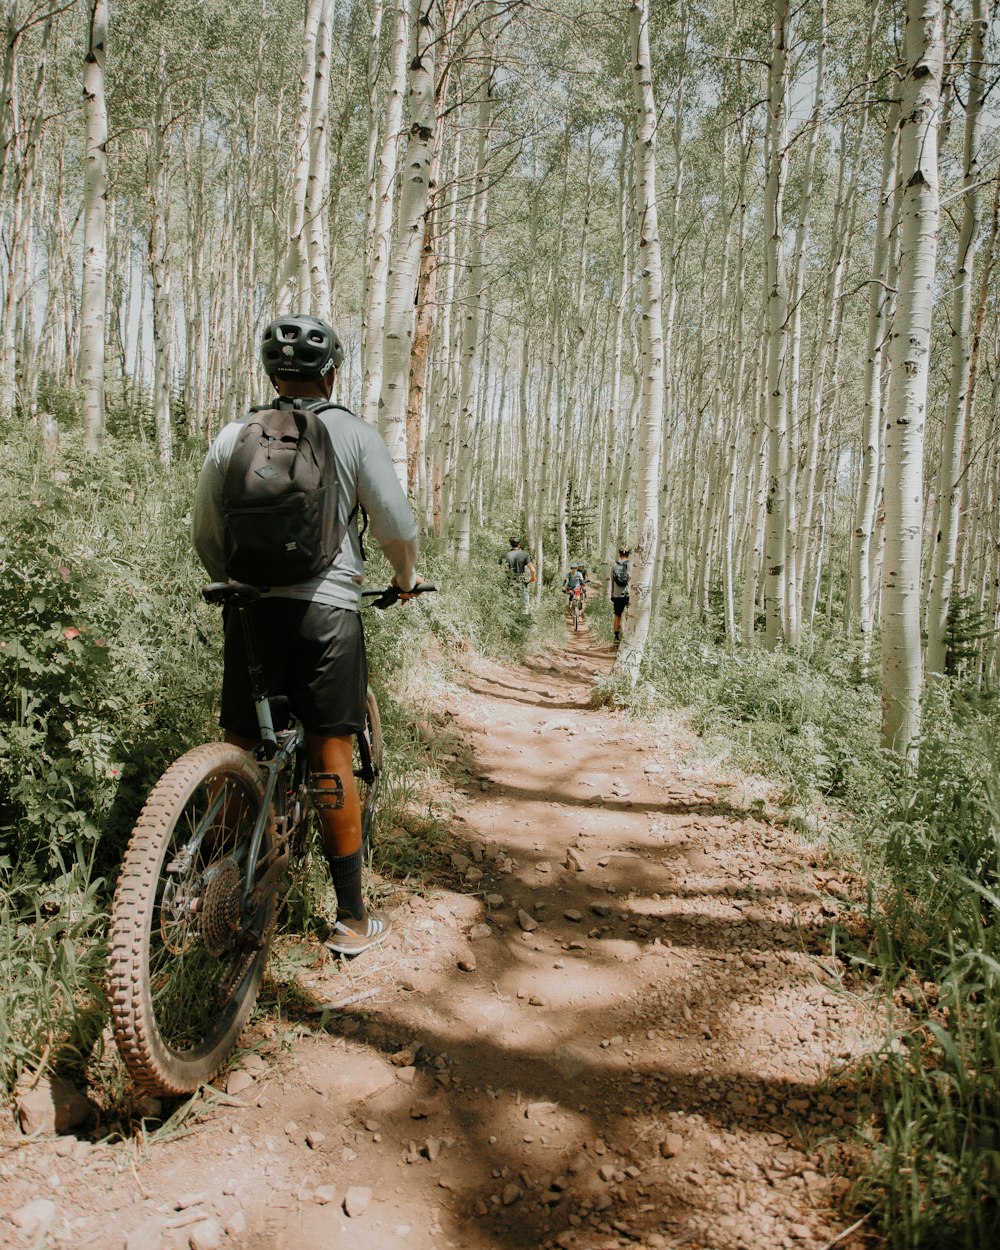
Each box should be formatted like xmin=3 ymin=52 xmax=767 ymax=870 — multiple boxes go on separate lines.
xmin=868 ymin=686 xmax=1000 ymax=1250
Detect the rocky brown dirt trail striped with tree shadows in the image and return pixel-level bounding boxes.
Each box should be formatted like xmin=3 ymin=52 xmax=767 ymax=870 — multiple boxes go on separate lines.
xmin=0 ymin=620 xmax=863 ymax=1250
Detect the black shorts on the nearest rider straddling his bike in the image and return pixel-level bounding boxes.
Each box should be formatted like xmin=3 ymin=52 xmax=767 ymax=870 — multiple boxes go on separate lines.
xmin=219 ymin=599 xmax=368 ymax=739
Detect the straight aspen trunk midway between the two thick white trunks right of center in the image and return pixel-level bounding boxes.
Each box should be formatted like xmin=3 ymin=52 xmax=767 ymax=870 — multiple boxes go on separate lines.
xmin=764 ymin=0 xmax=789 ymax=651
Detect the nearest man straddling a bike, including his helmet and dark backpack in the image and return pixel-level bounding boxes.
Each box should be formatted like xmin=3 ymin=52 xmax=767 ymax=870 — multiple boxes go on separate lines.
xmin=193 ymin=313 xmax=423 ymax=955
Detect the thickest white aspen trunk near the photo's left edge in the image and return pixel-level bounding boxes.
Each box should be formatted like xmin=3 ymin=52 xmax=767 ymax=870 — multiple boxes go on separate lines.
xmin=80 ymin=0 xmax=108 ymax=451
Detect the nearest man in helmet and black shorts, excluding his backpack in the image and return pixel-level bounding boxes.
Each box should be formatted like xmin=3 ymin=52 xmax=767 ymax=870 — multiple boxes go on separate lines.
xmin=193 ymin=314 xmax=421 ymax=955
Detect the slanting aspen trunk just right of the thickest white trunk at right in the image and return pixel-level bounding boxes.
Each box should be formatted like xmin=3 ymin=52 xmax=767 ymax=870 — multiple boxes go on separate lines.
xmin=925 ymin=0 xmax=990 ymax=674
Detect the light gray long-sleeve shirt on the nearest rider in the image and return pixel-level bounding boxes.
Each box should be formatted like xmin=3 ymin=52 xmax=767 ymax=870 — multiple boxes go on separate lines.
xmin=193 ymin=399 xmax=416 ymax=611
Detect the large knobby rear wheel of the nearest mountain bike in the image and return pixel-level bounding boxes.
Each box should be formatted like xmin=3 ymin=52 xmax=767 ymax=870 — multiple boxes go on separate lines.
xmin=108 ymin=743 xmax=275 ymax=1095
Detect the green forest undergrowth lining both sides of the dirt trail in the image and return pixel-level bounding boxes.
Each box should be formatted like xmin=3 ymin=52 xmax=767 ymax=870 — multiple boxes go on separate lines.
xmin=0 ymin=431 xmax=1000 ymax=1250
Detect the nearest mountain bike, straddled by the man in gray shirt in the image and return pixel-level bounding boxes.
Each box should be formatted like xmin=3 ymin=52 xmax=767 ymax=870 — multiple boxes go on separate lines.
xmin=108 ymin=583 xmax=435 ymax=1095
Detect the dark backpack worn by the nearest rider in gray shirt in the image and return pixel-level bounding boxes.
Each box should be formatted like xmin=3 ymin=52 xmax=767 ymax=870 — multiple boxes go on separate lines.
xmin=223 ymin=401 xmax=346 ymax=586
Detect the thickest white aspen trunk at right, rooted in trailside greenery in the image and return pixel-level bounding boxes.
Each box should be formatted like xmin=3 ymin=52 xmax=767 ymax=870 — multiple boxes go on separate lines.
xmin=883 ymin=0 xmax=944 ymax=755
